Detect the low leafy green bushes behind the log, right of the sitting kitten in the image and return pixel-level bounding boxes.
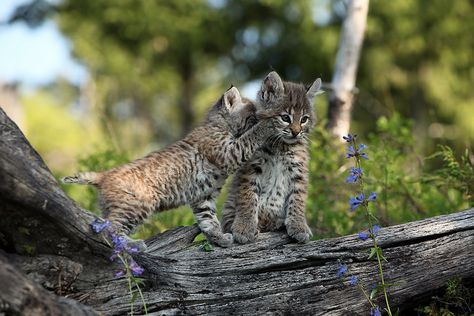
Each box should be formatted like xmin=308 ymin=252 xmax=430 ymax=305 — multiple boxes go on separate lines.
xmin=307 ymin=113 xmax=474 ymax=237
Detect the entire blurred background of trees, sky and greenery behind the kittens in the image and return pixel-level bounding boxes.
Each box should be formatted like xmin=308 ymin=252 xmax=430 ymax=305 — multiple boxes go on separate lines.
xmin=0 ymin=0 xmax=474 ymax=238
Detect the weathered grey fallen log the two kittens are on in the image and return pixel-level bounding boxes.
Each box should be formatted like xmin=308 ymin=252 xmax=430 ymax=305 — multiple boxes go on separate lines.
xmin=0 ymin=110 xmax=474 ymax=315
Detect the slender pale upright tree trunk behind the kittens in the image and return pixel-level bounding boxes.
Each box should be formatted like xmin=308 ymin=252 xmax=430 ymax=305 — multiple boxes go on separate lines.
xmin=327 ymin=0 xmax=369 ymax=138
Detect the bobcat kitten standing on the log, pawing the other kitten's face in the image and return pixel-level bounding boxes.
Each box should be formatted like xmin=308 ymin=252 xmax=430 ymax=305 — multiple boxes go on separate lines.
xmin=63 ymin=87 xmax=274 ymax=248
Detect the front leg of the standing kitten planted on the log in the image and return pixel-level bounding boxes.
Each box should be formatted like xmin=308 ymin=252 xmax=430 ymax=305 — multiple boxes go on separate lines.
xmin=191 ymin=198 xmax=234 ymax=247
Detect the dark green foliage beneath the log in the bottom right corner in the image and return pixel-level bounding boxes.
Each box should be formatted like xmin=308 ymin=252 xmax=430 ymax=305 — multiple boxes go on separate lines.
xmin=416 ymin=278 xmax=474 ymax=316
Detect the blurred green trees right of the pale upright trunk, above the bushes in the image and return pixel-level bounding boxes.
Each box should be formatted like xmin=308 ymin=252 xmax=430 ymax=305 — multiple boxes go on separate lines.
xmin=355 ymin=0 xmax=474 ymax=145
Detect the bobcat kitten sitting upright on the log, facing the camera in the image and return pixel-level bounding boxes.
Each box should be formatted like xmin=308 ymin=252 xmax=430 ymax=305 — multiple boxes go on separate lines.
xmin=222 ymin=72 xmax=322 ymax=243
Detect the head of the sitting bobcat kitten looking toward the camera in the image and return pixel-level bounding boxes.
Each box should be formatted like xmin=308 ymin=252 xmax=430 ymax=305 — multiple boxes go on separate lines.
xmin=258 ymin=72 xmax=321 ymax=144
